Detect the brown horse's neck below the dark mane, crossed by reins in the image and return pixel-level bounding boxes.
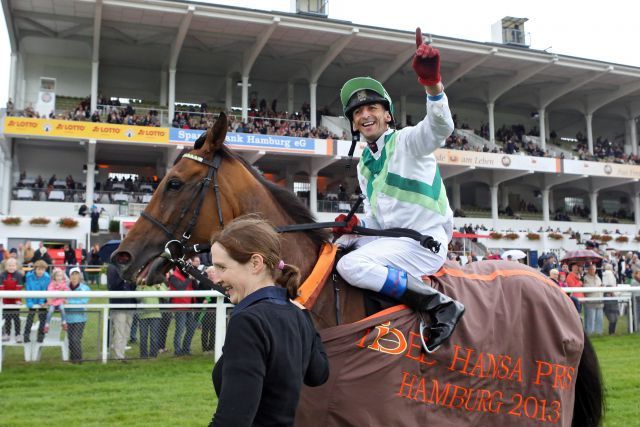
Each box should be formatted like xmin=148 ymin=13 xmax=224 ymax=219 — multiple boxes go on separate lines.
xmin=241 ymin=184 xmax=320 ymax=280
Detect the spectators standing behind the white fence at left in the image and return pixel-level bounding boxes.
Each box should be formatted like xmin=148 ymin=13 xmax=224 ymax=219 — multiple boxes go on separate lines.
xmin=0 ymin=241 xmax=216 ymax=363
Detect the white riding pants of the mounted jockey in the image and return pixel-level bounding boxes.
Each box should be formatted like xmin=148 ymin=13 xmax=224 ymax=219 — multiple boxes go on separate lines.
xmin=337 ymin=234 xmax=447 ymax=292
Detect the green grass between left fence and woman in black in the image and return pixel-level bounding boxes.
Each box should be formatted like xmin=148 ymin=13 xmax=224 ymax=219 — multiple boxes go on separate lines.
xmin=0 ymin=356 xmax=217 ymax=427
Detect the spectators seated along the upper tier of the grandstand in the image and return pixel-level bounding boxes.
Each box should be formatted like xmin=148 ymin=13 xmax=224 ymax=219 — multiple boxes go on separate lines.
xmin=7 ymin=95 xmax=640 ymax=164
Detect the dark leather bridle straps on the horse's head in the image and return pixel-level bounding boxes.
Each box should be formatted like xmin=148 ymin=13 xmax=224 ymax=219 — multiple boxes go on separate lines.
xmin=140 ymin=153 xmax=224 ymax=263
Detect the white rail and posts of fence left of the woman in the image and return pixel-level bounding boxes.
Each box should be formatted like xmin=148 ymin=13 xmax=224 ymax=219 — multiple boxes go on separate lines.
xmin=0 ymin=291 xmax=232 ymax=372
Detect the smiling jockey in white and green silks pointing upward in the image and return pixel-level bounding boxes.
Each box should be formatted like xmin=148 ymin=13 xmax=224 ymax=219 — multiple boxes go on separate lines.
xmin=334 ymin=28 xmax=464 ymax=352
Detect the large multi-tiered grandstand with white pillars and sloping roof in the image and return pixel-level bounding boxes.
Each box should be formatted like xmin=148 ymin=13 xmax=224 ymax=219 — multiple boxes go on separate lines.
xmin=0 ymin=0 xmax=640 ymax=260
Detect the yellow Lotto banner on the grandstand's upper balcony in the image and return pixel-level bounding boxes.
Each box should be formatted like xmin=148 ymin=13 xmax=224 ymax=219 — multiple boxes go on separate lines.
xmin=4 ymin=117 xmax=169 ymax=144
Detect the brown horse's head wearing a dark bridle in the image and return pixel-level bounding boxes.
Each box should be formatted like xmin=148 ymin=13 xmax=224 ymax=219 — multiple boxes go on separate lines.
xmin=111 ymin=113 xmax=237 ymax=283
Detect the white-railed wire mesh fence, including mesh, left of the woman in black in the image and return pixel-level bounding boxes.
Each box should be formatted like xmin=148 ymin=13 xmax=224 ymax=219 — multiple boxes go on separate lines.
xmin=0 ymin=291 xmax=232 ymax=370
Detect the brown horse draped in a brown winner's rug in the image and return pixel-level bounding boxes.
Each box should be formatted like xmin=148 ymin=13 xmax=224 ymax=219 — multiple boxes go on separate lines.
xmin=112 ymin=113 xmax=603 ymax=427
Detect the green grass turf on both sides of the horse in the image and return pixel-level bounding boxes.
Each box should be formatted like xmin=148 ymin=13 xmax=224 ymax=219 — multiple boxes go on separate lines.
xmin=0 ymin=334 xmax=640 ymax=427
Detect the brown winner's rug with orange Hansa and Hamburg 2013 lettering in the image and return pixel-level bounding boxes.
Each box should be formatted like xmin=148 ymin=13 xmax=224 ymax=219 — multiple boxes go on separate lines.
xmin=296 ymin=261 xmax=583 ymax=427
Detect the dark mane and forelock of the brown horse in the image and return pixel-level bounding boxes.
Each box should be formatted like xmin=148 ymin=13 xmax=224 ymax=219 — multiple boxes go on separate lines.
xmin=173 ymin=140 xmax=329 ymax=246
